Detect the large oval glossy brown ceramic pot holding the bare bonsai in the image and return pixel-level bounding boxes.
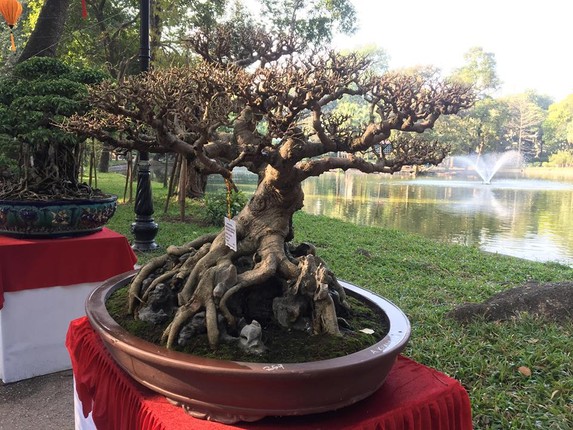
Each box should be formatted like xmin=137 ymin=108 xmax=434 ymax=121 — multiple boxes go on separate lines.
xmin=86 ymin=272 xmax=410 ymax=423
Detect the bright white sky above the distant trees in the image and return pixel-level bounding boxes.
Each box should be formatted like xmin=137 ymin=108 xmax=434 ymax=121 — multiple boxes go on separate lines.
xmin=334 ymin=0 xmax=573 ymax=102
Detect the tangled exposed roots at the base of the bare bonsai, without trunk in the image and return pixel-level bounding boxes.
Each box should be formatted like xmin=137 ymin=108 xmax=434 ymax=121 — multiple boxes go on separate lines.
xmin=130 ymin=228 xmax=347 ymax=348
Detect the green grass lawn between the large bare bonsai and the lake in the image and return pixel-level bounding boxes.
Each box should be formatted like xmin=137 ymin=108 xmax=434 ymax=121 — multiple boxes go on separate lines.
xmin=98 ymin=174 xmax=573 ymax=430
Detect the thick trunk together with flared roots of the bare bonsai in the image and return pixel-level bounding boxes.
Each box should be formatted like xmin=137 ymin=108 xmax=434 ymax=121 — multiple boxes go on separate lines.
xmin=130 ymin=167 xmax=346 ymax=347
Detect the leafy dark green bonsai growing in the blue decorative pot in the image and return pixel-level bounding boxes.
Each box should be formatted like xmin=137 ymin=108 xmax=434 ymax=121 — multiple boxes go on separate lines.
xmin=0 ymin=57 xmax=105 ymax=200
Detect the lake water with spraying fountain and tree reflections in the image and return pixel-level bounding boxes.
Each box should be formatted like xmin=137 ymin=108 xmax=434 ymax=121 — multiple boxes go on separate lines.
xmin=211 ymin=172 xmax=573 ymax=265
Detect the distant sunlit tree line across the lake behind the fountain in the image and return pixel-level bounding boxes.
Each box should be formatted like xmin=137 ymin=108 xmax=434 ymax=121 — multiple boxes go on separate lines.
xmin=330 ymin=47 xmax=573 ymax=166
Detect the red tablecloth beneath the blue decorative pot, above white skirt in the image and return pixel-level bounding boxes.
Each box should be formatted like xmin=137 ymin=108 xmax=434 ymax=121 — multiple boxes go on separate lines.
xmin=0 ymin=228 xmax=137 ymax=309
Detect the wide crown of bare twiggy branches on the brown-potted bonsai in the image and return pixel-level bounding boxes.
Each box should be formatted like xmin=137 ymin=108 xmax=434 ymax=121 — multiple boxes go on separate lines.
xmin=67 ymin=45 xmax=473 ymax=185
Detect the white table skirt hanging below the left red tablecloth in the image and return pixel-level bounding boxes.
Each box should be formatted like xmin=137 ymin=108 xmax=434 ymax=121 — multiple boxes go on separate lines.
xmin=0 ymin=282 xmax=101 ymax=383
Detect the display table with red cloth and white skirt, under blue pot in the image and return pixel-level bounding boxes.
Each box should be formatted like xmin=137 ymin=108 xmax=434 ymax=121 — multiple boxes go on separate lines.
xmin=0 ymin=228 xmax=137 ymax=382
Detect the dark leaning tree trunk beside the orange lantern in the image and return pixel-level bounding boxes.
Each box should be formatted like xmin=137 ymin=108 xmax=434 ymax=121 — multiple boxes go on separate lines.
xmin=18 ymin=0 xmax=70 ymax=63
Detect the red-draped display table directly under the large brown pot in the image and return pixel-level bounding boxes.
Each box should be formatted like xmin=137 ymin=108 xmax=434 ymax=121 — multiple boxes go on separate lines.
xmin=66 ymin=317 xmax=472 ymax=430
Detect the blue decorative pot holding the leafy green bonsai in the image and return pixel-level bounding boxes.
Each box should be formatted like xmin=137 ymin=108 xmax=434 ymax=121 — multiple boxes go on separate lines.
xmin=0 ymin=195 xmax=117 ymax=239
